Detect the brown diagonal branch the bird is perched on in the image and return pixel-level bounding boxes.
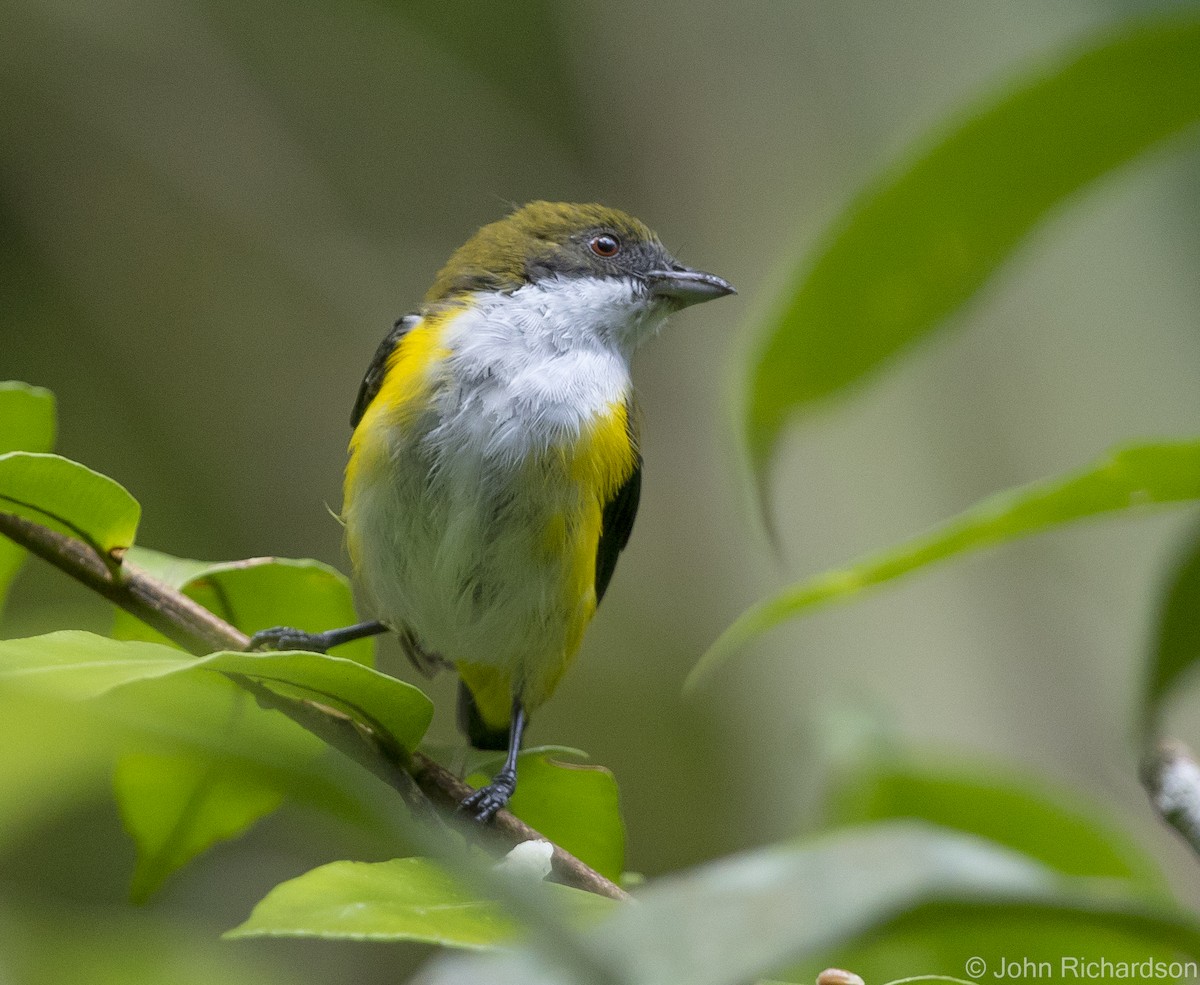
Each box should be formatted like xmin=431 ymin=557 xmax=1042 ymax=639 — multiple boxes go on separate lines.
xmin=0 ymin=512 xmax=630 ymax=900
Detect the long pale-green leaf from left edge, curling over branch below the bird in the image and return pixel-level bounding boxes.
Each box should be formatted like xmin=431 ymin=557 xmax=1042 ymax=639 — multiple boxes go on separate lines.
xmin=0 ymin=631 xmax=433 ymax=750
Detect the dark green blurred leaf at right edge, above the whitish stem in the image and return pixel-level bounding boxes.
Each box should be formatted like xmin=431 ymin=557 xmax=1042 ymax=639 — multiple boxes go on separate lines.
xmin=1142 ymin=530 xmax=1200 ymax=733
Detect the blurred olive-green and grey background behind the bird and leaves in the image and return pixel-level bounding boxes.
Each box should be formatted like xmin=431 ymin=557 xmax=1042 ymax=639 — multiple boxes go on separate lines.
xmin=0 ymin=0 xmax=1200 ymax=981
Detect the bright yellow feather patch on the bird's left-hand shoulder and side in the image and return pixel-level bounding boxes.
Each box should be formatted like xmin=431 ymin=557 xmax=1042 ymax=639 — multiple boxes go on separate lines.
xmin=342 ymin=304 xmax=468 ymax=567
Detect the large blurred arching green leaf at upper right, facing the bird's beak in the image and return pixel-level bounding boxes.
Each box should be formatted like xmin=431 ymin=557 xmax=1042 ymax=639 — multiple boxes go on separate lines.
xmin=746 ymin=11 xmax=1200 ymax=473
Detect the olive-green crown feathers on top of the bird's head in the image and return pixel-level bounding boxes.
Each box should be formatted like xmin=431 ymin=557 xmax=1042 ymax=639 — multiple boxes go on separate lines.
xmin=425 ymin=202 xmax=661 ymax=302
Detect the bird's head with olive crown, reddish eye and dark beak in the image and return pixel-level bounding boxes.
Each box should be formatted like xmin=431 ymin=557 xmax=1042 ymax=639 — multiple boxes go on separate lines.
xmin=425 ymin=202 xmax=734 ymax=350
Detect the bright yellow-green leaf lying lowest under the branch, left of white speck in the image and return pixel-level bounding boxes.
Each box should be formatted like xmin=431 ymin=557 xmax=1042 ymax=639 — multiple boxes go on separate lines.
xmin=226 ymin=858 xmax=616 ymax=945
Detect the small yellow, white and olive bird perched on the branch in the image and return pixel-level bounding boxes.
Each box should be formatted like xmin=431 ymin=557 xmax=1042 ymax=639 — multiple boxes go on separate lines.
xmin=253 ymin=202 xmax=734 ymax=822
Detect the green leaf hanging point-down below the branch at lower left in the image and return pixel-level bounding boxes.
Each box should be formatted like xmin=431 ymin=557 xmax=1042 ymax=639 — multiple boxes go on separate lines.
xmin=113 ymin=748 xmax=283 ymax=903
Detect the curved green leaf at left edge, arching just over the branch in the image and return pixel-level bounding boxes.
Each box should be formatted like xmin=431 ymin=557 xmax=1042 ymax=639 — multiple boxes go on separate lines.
xmin=0 ymin=451 xmax=142 ymax=557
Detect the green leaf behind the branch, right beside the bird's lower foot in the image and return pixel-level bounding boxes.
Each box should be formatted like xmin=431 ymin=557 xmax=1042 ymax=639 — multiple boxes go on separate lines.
xmin=467 ymin=746 xmax=625 ymax=881
